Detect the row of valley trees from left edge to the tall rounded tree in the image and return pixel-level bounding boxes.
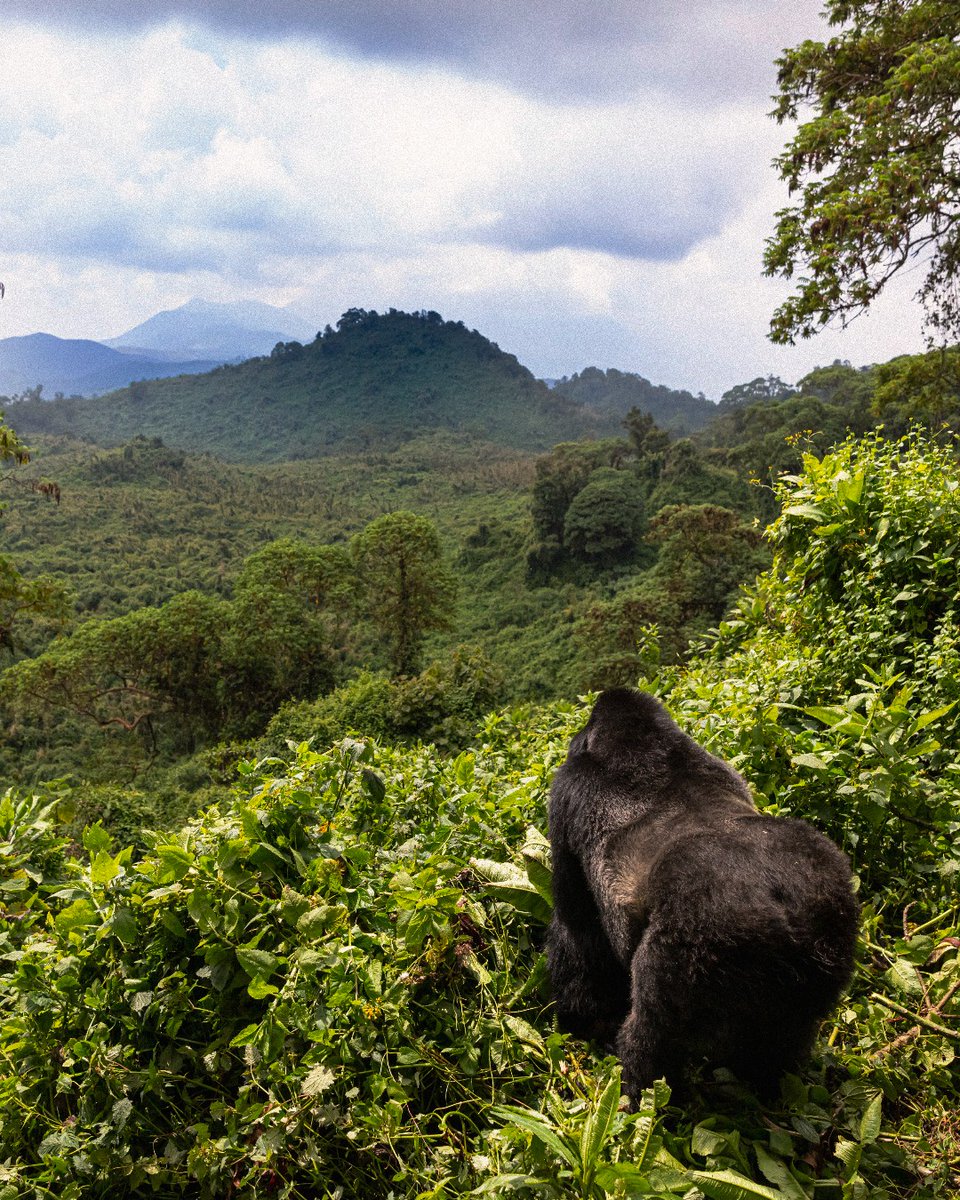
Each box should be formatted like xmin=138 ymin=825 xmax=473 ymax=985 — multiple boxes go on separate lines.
xmin=2 ymin=512 xmax=454 ymax=756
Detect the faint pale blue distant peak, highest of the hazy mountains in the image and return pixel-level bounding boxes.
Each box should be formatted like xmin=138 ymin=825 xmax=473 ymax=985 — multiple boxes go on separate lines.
xmin=103 ymin=300 xmax=317 ymax=362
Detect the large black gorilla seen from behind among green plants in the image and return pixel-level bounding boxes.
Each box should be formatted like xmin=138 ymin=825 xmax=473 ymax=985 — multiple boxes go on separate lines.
xmin=547 ymin=688 xmax=858 ymax=1099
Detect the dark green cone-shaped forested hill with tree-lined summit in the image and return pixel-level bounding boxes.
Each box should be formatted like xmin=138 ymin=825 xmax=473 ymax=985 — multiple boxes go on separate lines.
xmin=7 ymin=308 xmax=622 ymax=462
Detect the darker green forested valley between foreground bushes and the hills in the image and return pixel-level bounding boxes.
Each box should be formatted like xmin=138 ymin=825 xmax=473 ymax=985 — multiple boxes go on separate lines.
xmin=0 ymin=340 xmax=960 ymax=806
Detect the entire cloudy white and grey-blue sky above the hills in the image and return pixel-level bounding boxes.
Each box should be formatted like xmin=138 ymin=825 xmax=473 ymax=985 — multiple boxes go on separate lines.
xmin=0 ymin=0 xmax=922 ymax=398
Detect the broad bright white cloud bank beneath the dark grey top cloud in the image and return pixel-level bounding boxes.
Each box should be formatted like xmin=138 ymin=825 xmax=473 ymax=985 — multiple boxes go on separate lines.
xmin=0 ymin=22 xmax=769 ymax=271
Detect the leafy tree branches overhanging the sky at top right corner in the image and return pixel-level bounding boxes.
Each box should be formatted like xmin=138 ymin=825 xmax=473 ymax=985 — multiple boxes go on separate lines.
xmin=764 ymin=0 xmax=960 ymax=342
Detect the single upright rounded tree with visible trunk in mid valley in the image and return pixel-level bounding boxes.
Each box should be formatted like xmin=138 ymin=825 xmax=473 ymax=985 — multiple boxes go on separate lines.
xmin=352 ymin=511 xmax=456 ymax=676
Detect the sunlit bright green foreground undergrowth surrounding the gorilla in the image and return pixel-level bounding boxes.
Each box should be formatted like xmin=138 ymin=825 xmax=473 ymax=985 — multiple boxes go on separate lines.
xmin=0 ymin=437 xmax=960 ymax=1200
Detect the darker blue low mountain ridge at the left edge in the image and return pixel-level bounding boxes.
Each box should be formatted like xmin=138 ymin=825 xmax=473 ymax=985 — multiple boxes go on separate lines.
xmin=0 ymin=334 xmax=216 ymax=396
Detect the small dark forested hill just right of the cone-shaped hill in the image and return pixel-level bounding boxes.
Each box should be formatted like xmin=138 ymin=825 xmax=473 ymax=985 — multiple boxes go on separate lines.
xmin=553 ymin=367 xmax=716 ymax=436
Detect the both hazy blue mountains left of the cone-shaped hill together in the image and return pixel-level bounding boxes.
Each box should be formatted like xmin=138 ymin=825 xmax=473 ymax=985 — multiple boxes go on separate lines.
xmin=0 ymin=300 xmax=317 ymax=400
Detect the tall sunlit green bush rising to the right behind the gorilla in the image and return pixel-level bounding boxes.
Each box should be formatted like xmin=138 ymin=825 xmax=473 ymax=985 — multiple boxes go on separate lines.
xmin=662 ymin=436 xmax=960 ymax=911
